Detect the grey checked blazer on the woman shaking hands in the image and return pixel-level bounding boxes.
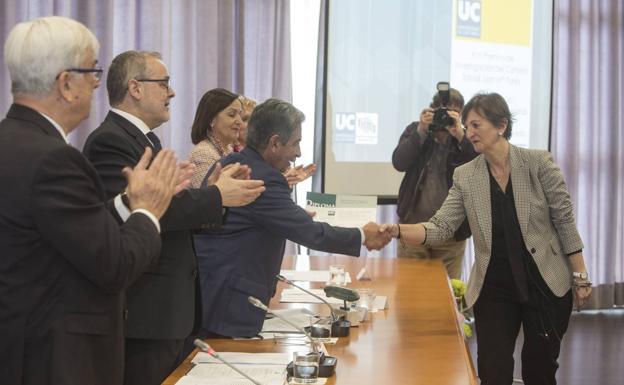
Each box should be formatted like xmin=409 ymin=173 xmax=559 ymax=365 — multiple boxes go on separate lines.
xmin=424 ymin=145 xmax=583 ymax=307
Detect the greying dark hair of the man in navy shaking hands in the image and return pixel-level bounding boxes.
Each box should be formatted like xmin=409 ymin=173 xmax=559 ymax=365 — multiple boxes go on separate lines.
xmin=247 ymin=98 xmax=305 ymax=151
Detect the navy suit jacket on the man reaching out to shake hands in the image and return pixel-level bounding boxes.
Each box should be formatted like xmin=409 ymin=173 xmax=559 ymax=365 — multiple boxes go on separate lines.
xmin=195 ymin=147 xmax=361 ymax=337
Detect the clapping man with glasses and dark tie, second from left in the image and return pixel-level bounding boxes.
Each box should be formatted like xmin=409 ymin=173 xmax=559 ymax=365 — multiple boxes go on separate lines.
xmin=83 ymin=51 xmax=264 ymax=385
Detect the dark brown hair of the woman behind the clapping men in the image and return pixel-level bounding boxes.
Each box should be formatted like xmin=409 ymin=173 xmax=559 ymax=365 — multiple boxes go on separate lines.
xmin=191 ymin=88 xmax=239 ymax=144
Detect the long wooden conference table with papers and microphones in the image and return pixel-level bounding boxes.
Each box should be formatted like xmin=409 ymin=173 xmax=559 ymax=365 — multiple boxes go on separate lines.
xmin=163 ymin=255 xmax=478 ymax=385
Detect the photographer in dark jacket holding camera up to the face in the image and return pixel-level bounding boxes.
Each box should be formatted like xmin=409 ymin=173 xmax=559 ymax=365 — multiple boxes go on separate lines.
xmin=392 ymin=82 xmax=477 ymax=279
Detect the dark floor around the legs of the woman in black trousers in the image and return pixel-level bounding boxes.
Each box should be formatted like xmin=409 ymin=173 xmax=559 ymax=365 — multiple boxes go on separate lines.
xmin=468 ymin=309 xmax=624 ymax=385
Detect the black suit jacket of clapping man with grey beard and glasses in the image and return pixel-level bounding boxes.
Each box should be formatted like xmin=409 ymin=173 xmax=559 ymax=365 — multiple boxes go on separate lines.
xmin=83 ymin=112 xmax=222 ymax=339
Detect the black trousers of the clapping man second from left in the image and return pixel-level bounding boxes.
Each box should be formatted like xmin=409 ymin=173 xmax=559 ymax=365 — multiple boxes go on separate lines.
xmin=124 ymin=338 xmax=184 ymax=385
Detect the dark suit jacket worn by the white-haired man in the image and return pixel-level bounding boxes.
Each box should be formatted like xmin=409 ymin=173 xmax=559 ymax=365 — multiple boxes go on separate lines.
xmin=0 ymin=105 xmax=160 ymax=385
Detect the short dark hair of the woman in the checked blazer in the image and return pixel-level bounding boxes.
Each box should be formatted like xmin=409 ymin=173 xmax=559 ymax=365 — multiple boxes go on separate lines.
xmin=462 ymin=92 xmax=514 ymax=140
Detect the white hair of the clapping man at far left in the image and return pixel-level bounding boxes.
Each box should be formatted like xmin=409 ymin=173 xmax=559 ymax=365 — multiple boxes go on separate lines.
xmin=4 ymin=16 xmax=100 ymax=98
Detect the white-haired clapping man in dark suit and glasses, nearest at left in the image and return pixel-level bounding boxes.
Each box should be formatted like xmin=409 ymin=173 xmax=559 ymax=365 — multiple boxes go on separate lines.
xmin=0 ymin=17 xmax=189 ymax=385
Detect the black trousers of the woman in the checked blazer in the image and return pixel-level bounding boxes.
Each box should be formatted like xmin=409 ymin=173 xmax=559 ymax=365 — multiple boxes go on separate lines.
xmin=474 ymin=269 xmax=572 ymax=385
